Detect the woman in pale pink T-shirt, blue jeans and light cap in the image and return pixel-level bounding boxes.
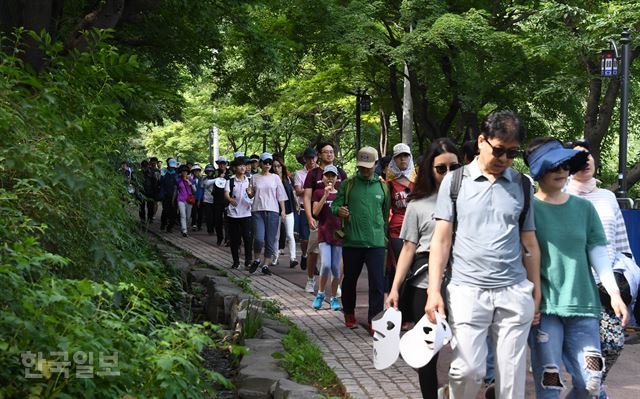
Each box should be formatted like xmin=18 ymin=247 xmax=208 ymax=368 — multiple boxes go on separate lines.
xmin=247 ymin=152 xmax=287 ymax=276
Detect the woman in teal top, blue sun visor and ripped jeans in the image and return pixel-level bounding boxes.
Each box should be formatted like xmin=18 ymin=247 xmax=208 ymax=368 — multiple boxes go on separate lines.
xmin=525 ymin=138 xmax=627 ymax=399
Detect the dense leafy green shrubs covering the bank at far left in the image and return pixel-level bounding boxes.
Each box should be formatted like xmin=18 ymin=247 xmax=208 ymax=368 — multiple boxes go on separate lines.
xmin=0 ymin=32 xmax=226 ymax=398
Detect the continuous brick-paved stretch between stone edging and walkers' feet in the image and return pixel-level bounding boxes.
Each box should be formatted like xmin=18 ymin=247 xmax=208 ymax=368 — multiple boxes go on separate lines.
xmin=150 ymin=225 xmax=422 ymax=399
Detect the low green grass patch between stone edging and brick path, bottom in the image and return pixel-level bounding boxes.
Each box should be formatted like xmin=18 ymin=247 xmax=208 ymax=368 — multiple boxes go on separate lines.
xmin=274 ymin=326 xmax=346 ymax=397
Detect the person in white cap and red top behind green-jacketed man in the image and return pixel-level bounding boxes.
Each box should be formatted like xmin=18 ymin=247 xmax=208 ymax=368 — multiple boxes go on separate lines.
xmin=385 ymin=143 xmax=416 ymax=300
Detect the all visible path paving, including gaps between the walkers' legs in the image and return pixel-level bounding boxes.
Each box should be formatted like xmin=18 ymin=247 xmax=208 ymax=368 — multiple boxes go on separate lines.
xmin=145 ymin=220 xmax=640 ymax=399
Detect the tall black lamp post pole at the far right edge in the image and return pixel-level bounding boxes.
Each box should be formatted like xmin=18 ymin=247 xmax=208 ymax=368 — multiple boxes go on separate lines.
xmin=616 ymin=27 xmax=631 ymax=198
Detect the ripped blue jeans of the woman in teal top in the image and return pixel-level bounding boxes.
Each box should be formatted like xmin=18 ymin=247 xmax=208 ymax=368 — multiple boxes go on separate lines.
xmin=529 ymin=314 xmax=604 ymax=399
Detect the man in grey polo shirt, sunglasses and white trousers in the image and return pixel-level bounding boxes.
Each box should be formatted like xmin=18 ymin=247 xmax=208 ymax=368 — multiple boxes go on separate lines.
xmin=425 ymin=111 xmax=540 ymax=399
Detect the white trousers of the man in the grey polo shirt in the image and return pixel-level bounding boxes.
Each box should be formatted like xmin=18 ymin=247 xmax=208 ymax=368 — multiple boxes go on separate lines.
xmin=447 ymin=280 xmax=534 ymax=399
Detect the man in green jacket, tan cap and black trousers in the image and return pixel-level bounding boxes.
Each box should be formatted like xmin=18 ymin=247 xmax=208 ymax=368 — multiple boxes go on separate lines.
xmin=331 ymin=147 xmax=390 ymax=332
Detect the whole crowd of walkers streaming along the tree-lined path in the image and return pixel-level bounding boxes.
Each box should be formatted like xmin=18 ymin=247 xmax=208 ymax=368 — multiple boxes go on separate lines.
xmin=125 ymin=111 xmax=640 ymax=399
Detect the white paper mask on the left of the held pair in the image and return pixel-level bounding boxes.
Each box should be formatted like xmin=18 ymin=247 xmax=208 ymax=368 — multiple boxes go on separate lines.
xmin=371 ymin=308 xmax=402 ymax=370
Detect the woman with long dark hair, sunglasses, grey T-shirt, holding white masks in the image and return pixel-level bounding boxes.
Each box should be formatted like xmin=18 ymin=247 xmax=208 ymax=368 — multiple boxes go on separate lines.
xmin=387 ymin=138 xmax=462 ymax=399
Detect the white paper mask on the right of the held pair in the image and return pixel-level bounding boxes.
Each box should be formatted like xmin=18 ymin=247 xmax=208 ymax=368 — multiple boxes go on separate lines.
xmin=400 ymin=312 xmax=452 ymax=368
